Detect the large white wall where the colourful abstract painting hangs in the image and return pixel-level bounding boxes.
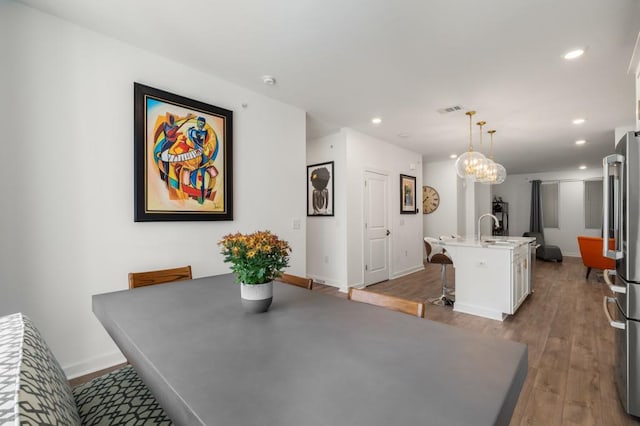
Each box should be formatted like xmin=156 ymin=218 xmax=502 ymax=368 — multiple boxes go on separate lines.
xmin=0 ymin=1 xmax=306 ymax=376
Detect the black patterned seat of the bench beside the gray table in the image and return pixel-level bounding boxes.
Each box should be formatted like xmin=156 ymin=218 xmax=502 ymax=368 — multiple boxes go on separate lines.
xmin=73 ymin=365 xmax=172 ymax=426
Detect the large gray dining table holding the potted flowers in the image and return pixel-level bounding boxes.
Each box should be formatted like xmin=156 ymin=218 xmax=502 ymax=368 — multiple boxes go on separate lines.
xmin=92 ymin=275 xmax=527 ymax=426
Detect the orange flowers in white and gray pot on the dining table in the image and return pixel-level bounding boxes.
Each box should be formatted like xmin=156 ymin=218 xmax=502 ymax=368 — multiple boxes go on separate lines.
xmin=218 ymin=231 xmax=291 ymax=313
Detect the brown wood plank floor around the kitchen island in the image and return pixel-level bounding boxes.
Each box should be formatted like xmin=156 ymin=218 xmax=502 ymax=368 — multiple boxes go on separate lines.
xmin=314 ymin=258 xmax=640 ymax=426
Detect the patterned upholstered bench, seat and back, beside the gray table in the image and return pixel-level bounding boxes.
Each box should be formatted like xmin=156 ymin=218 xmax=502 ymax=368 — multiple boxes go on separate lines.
xmin=0 ymin=313 xmax=171 ymax=426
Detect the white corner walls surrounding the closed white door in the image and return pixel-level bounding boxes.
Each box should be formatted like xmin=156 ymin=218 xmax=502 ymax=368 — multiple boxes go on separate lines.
xmin=307 ymin=128 xmax=423 ymax=291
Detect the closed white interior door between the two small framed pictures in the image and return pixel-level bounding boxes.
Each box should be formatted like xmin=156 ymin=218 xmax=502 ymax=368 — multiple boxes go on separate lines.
xmin=363 ymin=172 xmax=390 ymax=286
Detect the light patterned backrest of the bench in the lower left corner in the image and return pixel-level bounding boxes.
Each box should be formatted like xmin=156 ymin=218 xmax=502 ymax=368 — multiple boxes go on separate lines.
xmin=0 ymin=314 xmax=80 ymax=426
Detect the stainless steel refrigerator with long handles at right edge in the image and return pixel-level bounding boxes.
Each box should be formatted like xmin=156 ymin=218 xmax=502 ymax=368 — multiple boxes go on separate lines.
xmin=603 ymin=132 xmax=640 ymax=416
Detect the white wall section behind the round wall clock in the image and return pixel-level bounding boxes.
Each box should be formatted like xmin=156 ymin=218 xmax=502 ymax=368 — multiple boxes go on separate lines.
xmin=418 ymin=160 xmax=458 ymax=238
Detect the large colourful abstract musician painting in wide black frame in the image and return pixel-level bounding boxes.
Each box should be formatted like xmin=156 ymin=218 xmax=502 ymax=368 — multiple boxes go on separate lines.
xmin=134 ymin=83 xmax=233 ymax=222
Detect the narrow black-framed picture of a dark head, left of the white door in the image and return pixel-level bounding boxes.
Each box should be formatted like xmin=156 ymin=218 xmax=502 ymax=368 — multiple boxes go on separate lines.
xmin=307 ymin=161 xmax=335 ymax=216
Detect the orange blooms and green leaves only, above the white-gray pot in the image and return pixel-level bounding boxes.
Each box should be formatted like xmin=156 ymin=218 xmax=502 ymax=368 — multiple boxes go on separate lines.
xmin=218 ymin=231 xmax=291 ymax=284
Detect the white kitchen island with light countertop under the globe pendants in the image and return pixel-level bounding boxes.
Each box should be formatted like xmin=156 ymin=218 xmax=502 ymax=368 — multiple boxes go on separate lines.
xmin=442 ymin=237 xmax=534 ymax=321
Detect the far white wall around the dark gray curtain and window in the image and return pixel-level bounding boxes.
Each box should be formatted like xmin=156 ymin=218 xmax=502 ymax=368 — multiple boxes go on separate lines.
xmin=493 ymin=169 xmax=602 ymax=256
